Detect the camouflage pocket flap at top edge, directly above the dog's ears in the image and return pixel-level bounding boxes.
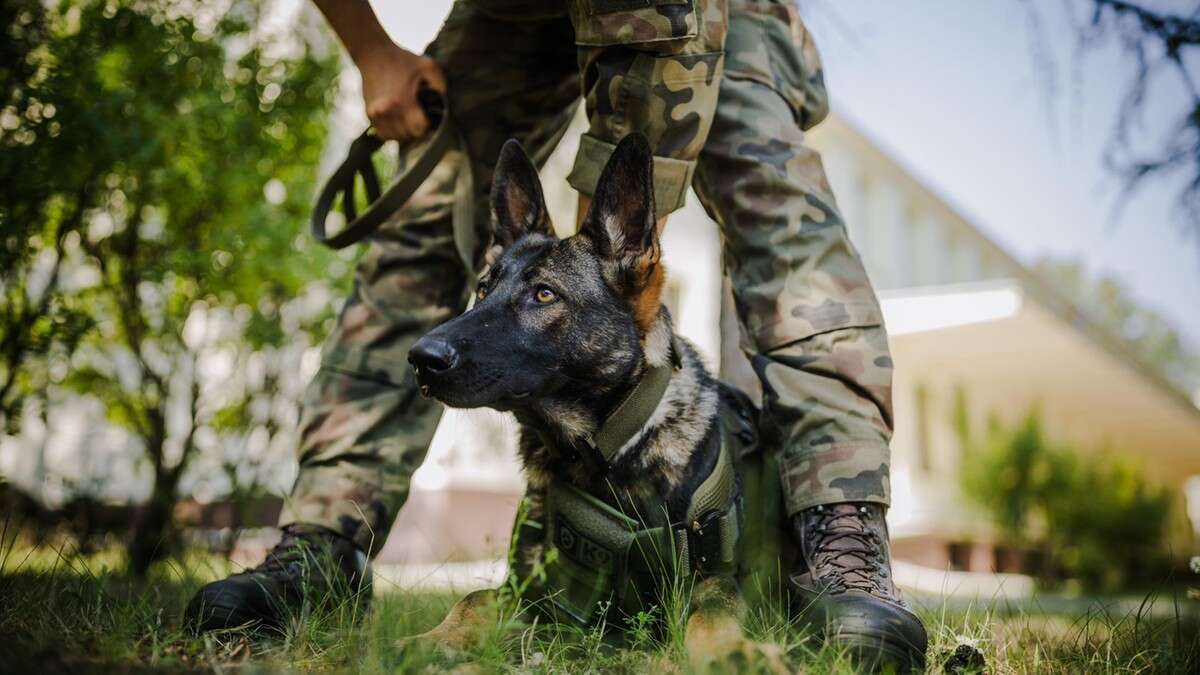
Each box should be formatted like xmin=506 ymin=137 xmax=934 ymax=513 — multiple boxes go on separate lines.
xmin=571 ymin=0 xmax=698 ymax=53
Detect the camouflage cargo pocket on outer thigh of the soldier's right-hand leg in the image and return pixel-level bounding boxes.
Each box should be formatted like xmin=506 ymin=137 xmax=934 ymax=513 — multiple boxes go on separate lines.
xmin=725 ymin=0 xmax=829 ymax=130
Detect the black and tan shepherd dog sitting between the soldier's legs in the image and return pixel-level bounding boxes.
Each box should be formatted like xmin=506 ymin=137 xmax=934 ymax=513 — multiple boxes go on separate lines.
xmin=409 ymin=135 xmax=787 ymax=671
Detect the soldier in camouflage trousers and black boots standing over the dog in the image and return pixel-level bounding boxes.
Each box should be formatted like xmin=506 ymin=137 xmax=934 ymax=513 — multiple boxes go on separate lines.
xmin=190 ymin=0 xmax=925 ymax=665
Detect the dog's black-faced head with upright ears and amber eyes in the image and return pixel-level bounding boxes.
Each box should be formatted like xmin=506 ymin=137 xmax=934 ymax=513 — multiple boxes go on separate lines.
xmin=408 ymin=135 xmax=664 ymax=410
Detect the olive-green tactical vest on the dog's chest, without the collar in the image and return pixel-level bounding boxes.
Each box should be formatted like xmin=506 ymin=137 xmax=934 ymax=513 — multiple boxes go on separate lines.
xmin=520 ymin=393 xmax=742 ymax=626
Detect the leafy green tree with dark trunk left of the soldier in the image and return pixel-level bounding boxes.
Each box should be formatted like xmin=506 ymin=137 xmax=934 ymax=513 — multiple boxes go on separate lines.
xmin=0 ymin=0 xmax=348 ymax=571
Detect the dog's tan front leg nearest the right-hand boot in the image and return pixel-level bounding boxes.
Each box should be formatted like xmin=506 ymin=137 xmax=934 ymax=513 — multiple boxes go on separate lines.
xmin=684 ymin=577 xmax=791 ymax=674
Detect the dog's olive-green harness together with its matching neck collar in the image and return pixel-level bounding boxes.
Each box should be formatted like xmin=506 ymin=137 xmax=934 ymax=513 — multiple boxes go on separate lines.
xmin=544 ymin=351 xmax=754 ymax=626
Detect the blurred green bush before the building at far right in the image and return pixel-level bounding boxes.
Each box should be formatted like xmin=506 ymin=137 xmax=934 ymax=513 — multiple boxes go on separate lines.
xmin=961 ymin=403 xmax=1171 ymax=591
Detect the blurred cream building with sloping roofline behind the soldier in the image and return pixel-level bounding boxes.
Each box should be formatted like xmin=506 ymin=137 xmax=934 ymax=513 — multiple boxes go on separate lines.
xmin=382 ymin=112 xmax=1200 ymax=581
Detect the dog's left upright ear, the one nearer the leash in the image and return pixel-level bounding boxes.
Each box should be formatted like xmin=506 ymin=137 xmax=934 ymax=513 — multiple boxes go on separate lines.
xmin=492 ymin=138 xmax=554 ymax=246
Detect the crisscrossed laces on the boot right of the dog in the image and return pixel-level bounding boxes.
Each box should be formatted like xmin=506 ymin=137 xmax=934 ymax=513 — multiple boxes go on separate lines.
xmin=806 ymin=503 xmax=889 ymax=597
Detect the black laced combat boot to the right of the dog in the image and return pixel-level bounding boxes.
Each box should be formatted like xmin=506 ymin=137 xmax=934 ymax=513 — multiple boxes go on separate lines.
xmin=792 ymin=503 xmax=928 ymax=671
